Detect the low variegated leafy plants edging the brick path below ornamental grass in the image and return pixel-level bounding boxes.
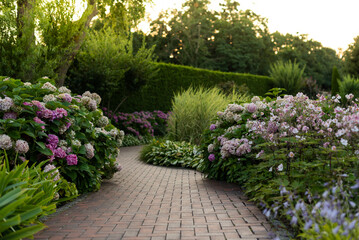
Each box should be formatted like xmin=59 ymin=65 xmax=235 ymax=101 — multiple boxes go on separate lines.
xmin=140 ymin=139 xmax=203 ymax=168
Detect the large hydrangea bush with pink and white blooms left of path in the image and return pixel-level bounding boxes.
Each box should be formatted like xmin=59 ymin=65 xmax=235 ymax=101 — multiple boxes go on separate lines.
xmin=0 ymin=77 xmax=123 ymax=192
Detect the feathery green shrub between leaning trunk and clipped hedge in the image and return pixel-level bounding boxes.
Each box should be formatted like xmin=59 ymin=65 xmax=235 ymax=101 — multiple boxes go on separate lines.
xmin=68 ymin=28 xmax=157 ymax=109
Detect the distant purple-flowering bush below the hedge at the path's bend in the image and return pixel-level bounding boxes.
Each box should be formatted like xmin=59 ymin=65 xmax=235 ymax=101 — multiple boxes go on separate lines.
xmin=103 ymin=108 xmax=169 ymax=140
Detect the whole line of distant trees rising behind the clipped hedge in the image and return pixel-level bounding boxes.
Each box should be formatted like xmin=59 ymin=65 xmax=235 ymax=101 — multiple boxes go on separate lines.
xmin=139 ymin=0 xmax=340 ymax=88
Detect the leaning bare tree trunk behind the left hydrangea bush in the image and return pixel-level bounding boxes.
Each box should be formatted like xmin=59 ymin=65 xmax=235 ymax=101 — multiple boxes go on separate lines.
xmin=57 ymin=2 xmax=98 ymax=87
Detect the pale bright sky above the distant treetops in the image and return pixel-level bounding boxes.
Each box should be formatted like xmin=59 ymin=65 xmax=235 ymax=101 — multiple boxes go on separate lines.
xmin=140 ymin=0 xmax=359 ymax=52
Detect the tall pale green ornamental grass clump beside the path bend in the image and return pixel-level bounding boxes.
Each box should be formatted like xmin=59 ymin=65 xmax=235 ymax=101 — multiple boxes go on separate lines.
xmin=168 ymin=87 xmax=248 ymax=144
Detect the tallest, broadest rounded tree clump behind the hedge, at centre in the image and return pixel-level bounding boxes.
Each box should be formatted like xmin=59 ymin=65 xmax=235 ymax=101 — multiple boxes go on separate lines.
xmin=147 ymin=0 xmax=274 ymax=74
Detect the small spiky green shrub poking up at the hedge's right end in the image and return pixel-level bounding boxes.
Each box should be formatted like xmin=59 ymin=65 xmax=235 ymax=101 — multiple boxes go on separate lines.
xmin=269 ymin=60 xmax=305 ymax=94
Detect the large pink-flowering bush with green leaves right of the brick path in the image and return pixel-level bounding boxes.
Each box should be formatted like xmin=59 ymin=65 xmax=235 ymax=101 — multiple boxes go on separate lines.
xmin=201 ymin=93 xmax=359 ymax=238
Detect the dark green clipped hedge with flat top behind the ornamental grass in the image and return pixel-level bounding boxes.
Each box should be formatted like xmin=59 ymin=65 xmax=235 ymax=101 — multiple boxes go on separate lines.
xmin=120 ymin=63 xmax=273 ymax=112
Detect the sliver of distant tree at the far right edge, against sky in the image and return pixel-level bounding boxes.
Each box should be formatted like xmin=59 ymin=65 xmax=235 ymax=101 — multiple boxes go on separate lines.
xmin=343 ymin=36 xmax=359 ymax=77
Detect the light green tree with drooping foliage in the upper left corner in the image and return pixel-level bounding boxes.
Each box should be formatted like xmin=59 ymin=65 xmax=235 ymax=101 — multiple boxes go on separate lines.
xmin=0 ymin=0 xmax=146 ymax=85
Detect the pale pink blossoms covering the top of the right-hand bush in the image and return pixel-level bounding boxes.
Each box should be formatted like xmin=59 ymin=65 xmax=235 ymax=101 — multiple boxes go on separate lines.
xmin=210 ymin=93 xmax=359 ymax=162
